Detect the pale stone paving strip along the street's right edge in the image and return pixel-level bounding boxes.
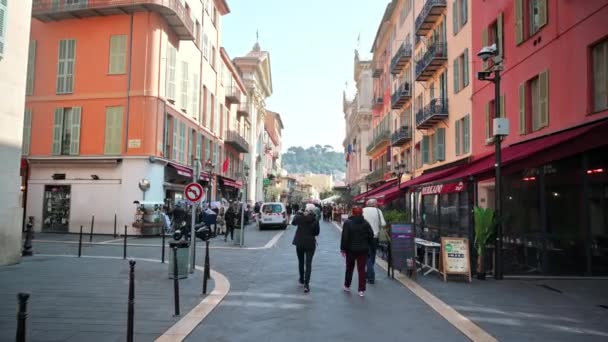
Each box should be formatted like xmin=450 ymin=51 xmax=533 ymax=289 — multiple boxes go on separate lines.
xmin=332 ymin=222 xmax=498 ymax=342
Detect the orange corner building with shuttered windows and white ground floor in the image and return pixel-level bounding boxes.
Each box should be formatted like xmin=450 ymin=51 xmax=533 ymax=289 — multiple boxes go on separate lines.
xmin=24 ymin=0 xmax=248 ymax=234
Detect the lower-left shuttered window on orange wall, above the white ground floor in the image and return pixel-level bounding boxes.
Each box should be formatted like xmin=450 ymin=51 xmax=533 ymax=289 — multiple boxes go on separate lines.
xmin=53 ymin=107 xmax=82 ymax=155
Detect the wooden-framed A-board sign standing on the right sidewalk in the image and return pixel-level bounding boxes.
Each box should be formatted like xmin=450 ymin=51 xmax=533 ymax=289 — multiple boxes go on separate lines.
xmin=441 ymin=237 xmax=471 ymax=282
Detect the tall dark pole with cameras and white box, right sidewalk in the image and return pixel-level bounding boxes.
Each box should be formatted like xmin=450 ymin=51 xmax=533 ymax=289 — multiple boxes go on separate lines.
xmin=477 ymin=44 xmax=509 ymax=280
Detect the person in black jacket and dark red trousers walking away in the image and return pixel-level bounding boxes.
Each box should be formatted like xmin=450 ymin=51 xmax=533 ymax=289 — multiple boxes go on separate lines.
xmin=340 ymin=208 xmax=374 ymax=297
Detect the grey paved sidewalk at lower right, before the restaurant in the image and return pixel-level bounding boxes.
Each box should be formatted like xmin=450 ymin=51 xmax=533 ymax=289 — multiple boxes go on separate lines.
xmin=417 ymin=274 xmax=608 ymax=342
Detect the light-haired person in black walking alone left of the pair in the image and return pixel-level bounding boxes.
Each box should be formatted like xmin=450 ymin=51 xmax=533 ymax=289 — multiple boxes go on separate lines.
xmin=293 ymin=203 xmax=320 ymax=292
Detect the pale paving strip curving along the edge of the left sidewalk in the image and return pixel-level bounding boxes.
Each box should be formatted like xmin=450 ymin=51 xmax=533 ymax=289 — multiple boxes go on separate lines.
xmin=34 ymin=254 xmax=230 ymax=342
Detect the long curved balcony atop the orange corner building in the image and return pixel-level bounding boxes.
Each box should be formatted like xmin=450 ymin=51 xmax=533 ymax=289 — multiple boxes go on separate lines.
xmin=32 ymin=0 xmax=194 ymax=40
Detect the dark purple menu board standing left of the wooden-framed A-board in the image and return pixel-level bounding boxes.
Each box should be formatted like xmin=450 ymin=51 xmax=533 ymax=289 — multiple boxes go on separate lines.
xmin=391 ymin=223 xmax=416 ymax=271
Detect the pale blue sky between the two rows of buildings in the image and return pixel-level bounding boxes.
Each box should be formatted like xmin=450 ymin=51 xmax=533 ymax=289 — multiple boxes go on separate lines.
xmin=221 ymin=0 xmax=388 ymax=151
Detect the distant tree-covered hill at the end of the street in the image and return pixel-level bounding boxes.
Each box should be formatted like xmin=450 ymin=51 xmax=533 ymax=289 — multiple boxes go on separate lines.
xmin=282 ymin=144 xmax=346 ymax=175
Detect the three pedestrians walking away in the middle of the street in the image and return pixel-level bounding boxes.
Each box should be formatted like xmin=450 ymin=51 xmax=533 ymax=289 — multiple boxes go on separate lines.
xmin=292 ymin=199 xmax=386 ymax=297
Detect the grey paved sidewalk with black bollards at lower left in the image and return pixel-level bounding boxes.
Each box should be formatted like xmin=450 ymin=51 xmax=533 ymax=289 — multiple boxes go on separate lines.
xmin=0 ymin=256 xmax=213 ymax=342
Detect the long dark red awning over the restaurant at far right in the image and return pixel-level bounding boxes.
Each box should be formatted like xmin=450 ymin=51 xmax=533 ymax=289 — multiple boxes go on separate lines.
xmin=403 ymin=120 xmax=608 ymax=187
